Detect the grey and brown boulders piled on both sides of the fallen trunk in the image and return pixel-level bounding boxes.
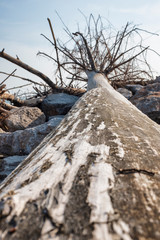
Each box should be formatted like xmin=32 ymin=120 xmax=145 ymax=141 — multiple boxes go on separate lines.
xmin=0 ymin=78 xmax=160 ymax=182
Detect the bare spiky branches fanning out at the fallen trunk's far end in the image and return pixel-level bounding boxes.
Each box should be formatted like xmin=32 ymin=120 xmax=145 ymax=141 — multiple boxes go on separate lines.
xmin=38 ymin=14 xmax=157 ymax=87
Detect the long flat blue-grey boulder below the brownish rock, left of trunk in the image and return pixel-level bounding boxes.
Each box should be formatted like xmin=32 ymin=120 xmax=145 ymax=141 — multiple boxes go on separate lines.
xmin=0 ymin=116 xmax=64 ymax=155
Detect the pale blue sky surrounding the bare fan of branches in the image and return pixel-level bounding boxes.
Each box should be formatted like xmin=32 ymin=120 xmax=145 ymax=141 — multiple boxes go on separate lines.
xmin=0 ymin=0 xmax=160 ymax=92
